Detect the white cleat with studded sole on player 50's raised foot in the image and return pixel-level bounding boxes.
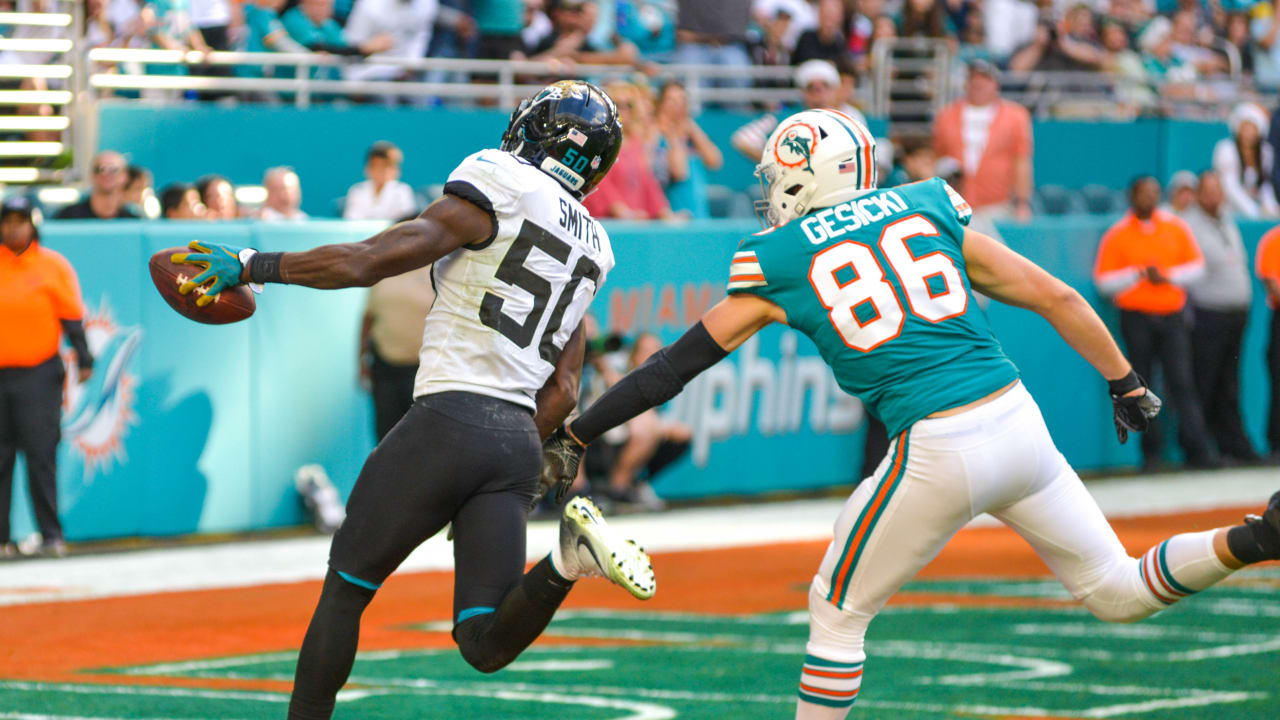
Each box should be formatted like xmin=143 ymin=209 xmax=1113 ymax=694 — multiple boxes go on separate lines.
xmin=561 ymin=497 xmax=658 ymax=600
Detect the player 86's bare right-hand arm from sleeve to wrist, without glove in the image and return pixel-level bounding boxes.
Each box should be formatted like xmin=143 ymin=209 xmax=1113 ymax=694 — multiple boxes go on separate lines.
xmin=964 ymin=231 xmax=1132 ymax=380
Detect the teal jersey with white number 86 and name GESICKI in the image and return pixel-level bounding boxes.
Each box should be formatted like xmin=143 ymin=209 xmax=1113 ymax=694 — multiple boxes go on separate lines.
xmin=728 ymin=178 xmax=1018 ymax=437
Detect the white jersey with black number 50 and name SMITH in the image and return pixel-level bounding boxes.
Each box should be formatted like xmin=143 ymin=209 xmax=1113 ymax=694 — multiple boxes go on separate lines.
xmin=413 ymin=150 xmax=613 ymax=407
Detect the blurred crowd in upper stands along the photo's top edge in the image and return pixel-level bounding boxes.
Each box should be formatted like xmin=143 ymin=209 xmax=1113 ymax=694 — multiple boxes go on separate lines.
xmin=45 ymin=0 xmax=1280 ymax=92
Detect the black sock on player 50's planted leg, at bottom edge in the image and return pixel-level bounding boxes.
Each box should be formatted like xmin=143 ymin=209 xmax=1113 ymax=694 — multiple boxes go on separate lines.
xmin=289 ymin=570 xmax=374 ymax=720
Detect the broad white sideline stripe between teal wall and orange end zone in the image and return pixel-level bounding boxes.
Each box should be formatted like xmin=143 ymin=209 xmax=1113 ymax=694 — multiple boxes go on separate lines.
xmin=0 ymin=468 xmax=1280 ymax=606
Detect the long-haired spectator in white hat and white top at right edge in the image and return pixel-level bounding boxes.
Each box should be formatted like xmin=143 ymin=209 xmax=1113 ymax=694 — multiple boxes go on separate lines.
xmin=1213 ymin=102 xmax=1280 ymax=218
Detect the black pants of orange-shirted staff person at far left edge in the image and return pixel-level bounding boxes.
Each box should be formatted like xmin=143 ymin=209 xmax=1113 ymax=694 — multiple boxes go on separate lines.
xmin=0 ymin=355 xmax=67 ymax=543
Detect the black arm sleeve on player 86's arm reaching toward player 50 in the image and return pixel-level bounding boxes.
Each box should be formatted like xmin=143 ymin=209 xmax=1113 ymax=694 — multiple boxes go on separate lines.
xmin=570 ymin=323 xmax=728 ymax=443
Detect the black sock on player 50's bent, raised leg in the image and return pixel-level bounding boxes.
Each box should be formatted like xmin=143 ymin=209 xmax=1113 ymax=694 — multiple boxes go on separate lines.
xmin=453 ymin=557 xmax=573 ymax=673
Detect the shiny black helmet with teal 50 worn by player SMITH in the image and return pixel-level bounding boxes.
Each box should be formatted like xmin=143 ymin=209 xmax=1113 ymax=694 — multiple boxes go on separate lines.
xmin=502 ymin=79 xmax=622 ymax=200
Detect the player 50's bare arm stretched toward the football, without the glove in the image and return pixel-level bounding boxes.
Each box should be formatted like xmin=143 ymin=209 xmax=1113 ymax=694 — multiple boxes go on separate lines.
xmin=241 ymin=195 xmax=493 ymax=290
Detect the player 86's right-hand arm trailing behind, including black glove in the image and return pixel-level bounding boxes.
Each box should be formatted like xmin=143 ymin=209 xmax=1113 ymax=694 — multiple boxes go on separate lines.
xmin=964 ymin=229 xmax=1161 ymax=443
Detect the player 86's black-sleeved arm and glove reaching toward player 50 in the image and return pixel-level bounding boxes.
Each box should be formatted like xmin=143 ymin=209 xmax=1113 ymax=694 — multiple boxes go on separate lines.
xmin=541 ymin=295 xmax=786 ymax=500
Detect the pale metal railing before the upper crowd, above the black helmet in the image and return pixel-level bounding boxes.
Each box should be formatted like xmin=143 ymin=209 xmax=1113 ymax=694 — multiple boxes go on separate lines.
xmin=88 ymin=47 xmax=800 ymax=109
